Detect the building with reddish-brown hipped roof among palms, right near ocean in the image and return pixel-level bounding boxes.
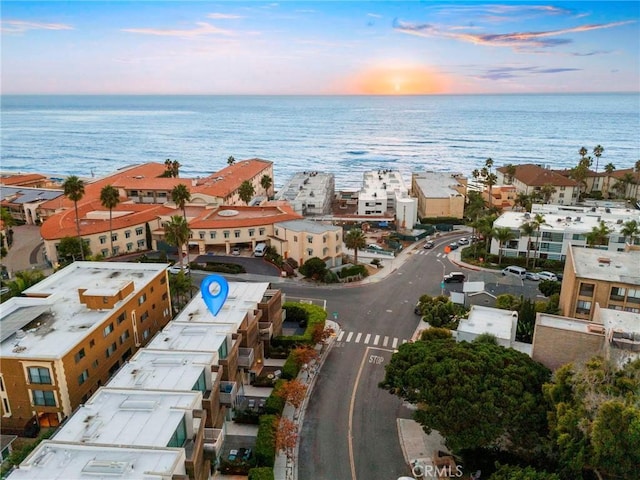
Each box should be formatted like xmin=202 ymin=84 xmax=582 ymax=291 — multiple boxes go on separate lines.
xmin=496 ymin=163 xmax=580 ymax=205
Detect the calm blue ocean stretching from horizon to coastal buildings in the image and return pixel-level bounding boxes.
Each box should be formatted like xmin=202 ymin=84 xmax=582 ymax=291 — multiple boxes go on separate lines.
xmin=0 ymin=94 xmax=640 ymax=189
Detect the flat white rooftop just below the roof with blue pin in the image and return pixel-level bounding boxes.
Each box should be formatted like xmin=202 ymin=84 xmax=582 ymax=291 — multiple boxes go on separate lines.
xmin=147 ymin=321 xmax=231 ymax=353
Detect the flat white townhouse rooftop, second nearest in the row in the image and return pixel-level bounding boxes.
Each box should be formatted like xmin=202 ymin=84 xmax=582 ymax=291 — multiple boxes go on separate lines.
xmin=53 ymin=387 xmax=202 ymax=447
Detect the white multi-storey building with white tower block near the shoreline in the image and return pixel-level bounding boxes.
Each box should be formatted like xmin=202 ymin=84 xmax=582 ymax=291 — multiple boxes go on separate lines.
xmin=357 ymin=170 xmax=418 ymax=229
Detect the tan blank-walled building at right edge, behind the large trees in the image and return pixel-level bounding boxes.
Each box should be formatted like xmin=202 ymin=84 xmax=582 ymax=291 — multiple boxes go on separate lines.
xmin=532 ymin=303 xmax=640 ymax=370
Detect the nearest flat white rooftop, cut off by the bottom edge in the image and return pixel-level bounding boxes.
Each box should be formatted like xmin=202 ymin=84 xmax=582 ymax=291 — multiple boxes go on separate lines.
xmin=8 ymin=440 xmax=186 ymax=480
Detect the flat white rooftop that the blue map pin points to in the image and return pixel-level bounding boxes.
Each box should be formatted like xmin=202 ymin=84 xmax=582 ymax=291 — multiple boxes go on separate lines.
xmin=174 ymin=282 xmax=269 ymax=326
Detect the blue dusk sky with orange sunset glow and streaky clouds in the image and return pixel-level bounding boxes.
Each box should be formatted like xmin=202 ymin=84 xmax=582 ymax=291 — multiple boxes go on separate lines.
xmin=1 ymin=1 xmax=640 ymax=95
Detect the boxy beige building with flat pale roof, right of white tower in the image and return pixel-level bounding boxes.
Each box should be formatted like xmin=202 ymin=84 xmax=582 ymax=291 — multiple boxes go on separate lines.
xmin=411 ymin=172 xmax=467 ymax=218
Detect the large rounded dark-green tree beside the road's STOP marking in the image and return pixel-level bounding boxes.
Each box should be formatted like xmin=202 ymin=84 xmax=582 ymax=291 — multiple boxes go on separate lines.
xmin=380 ymin=338 xmax=550 ymax=457
